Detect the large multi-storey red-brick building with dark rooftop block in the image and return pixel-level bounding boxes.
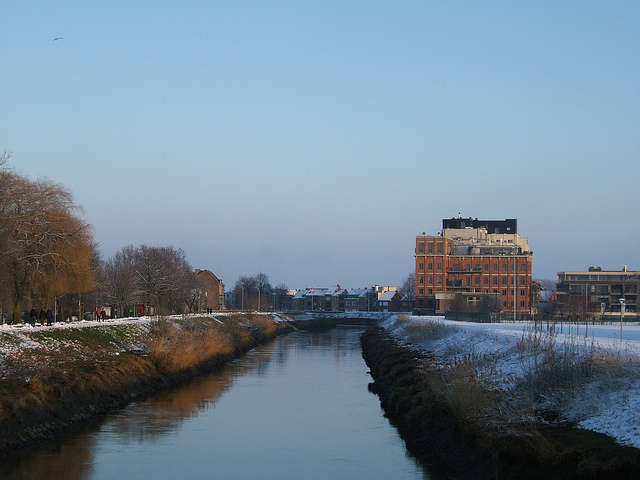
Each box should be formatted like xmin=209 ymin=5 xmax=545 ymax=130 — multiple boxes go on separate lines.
xmin=415 ymin=217 xmax=533 ymax=313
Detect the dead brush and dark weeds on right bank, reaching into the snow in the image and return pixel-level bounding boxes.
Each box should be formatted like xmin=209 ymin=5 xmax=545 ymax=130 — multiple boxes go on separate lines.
xmin=362 ymin=320 xmax=640 ymax=478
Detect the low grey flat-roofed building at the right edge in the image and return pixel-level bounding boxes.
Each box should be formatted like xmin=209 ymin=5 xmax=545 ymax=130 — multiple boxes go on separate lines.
xmin=556 ymin=266 xmax=640 ymax=315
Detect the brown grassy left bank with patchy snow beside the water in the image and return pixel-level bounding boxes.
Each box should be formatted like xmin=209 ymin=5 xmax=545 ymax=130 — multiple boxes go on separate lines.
xmin=0 ymin=314 xmax=290 ymax=455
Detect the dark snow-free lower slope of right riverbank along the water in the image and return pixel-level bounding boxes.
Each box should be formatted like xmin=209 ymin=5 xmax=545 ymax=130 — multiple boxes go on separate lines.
xmin=362 ymin=322 xmax=640 ymax=479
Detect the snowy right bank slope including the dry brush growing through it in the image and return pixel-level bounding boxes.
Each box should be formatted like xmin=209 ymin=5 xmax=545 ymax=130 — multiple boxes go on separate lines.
xmin=382 ymin=315 xmax=640 ymax=448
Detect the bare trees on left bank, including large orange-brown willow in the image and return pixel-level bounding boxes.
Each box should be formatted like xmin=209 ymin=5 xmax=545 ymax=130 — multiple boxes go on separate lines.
xmin=0 ymin=152 xmax=203 ymax=322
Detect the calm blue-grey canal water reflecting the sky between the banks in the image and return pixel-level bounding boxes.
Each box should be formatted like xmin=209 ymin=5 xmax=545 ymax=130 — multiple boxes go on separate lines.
xmin=0 ymin=328 xmax=429 ymax=480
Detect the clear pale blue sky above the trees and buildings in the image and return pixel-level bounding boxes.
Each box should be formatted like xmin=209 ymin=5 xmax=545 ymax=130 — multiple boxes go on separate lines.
xmin=0 ymin=0 xmax=640 ymax=288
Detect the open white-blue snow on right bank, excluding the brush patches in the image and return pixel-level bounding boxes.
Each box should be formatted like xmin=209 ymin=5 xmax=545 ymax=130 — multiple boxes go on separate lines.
xmin=382 ymin=317 xmax=640 ymax=448
